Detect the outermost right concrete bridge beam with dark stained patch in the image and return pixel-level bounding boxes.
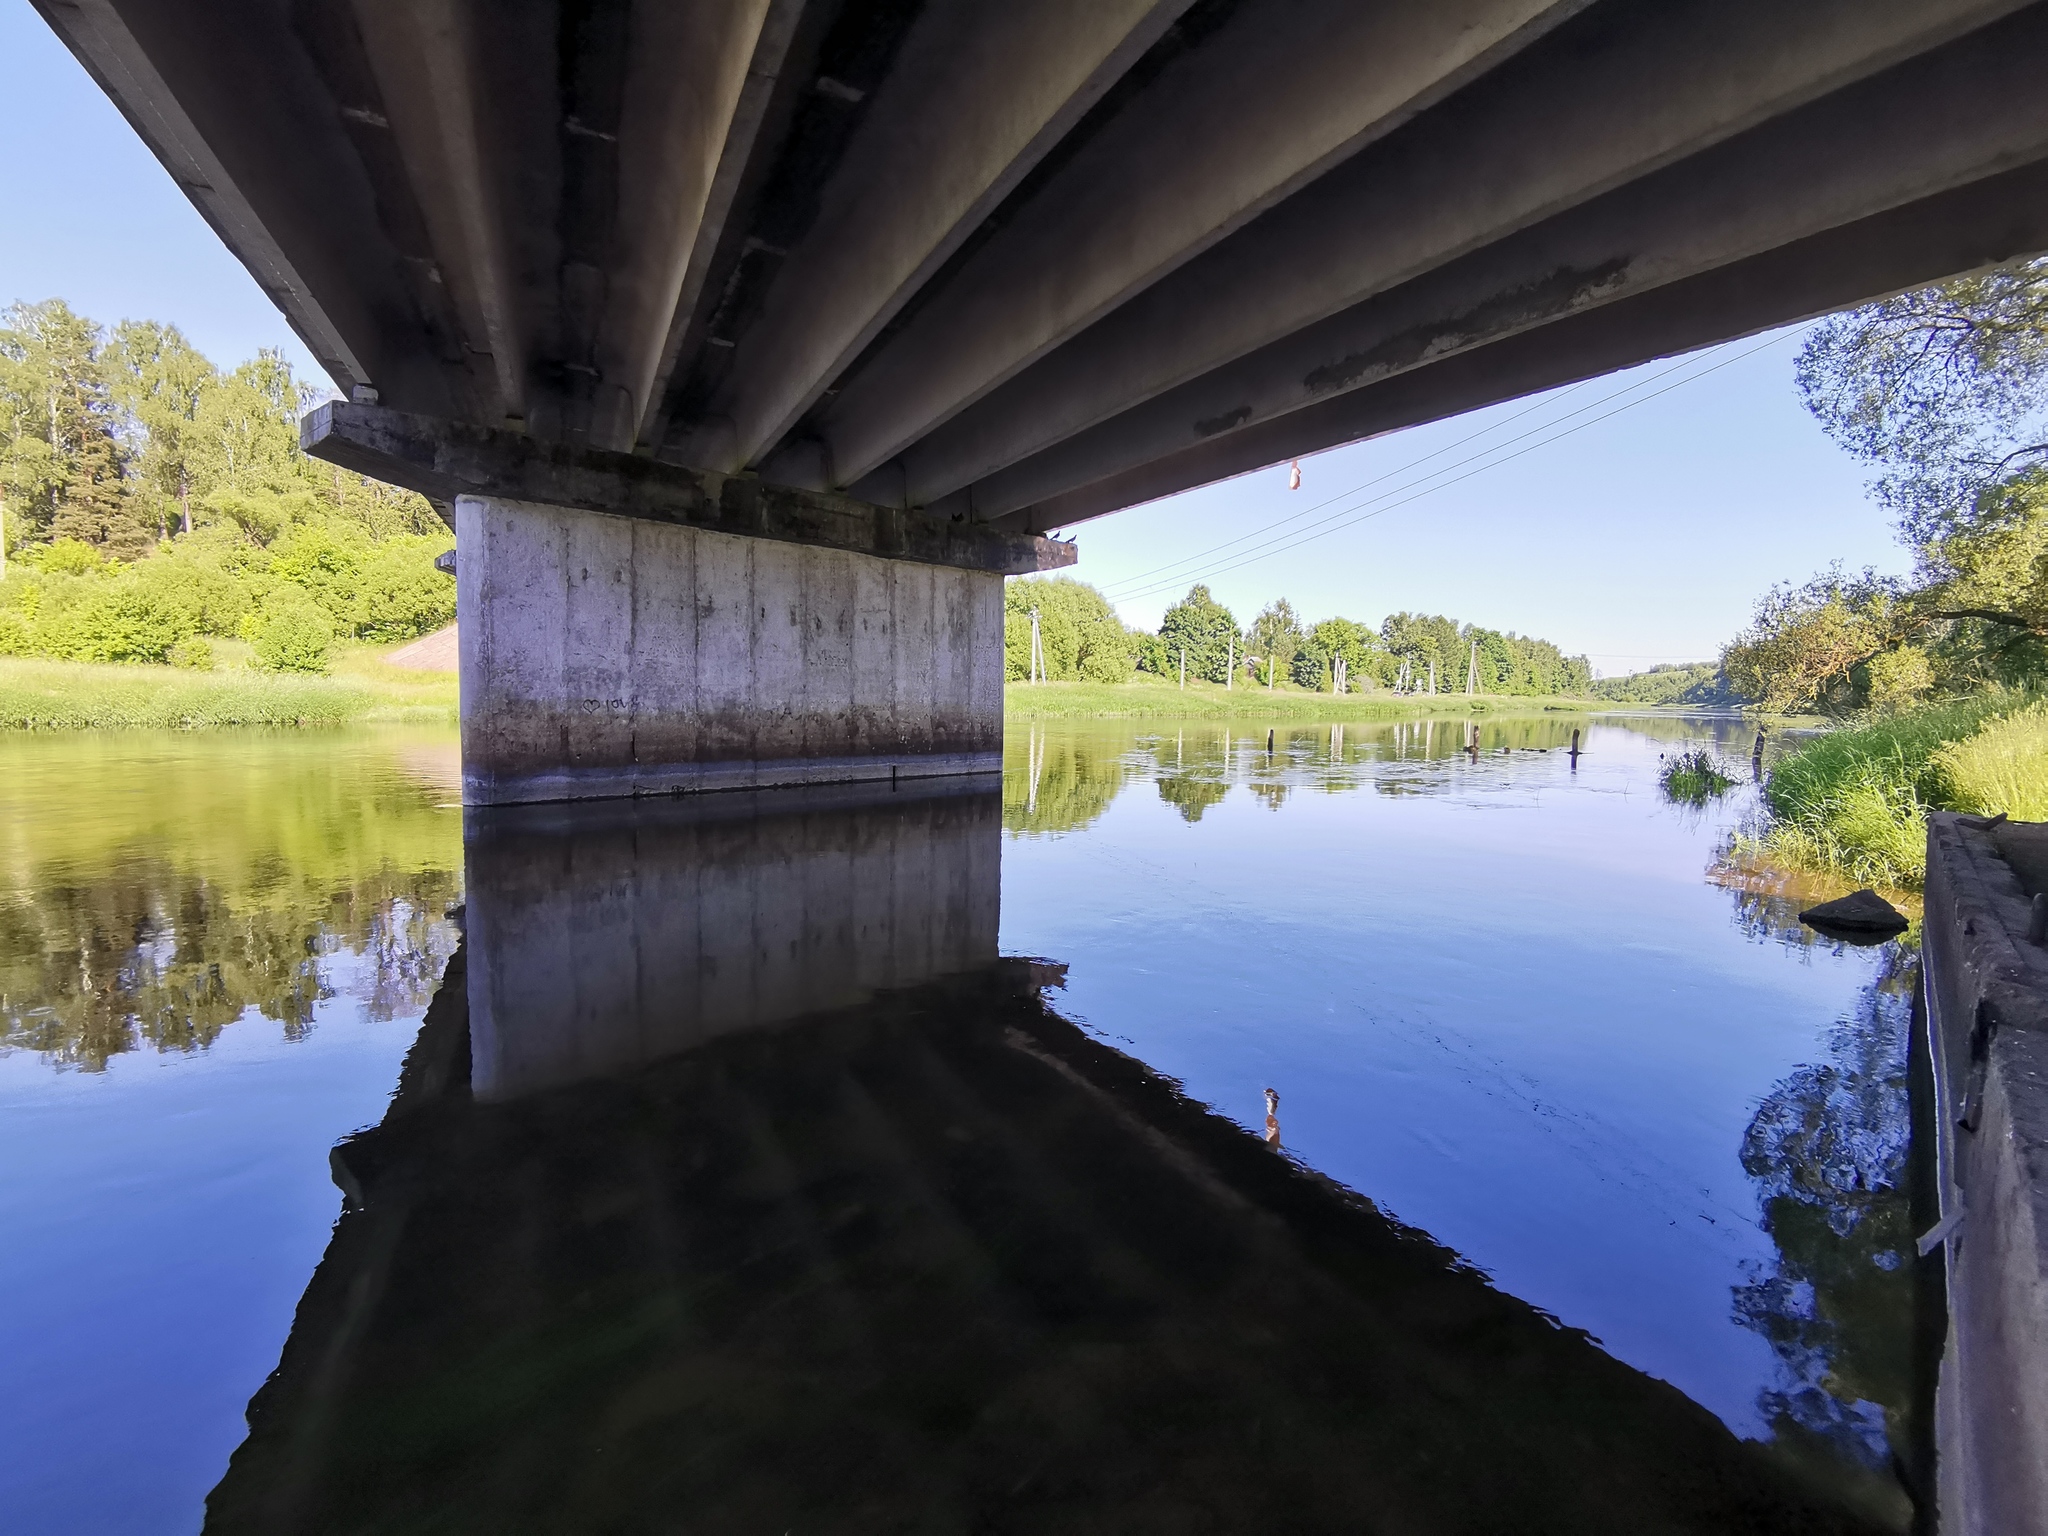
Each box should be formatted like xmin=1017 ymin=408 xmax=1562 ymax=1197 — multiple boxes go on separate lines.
xmin=938 ymin=12 xmax=2048 ymax=518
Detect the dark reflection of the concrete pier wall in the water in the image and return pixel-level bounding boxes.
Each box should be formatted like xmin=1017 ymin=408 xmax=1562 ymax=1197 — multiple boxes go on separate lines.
xmin=463 ymin=778 xmax=1001 ymax=1100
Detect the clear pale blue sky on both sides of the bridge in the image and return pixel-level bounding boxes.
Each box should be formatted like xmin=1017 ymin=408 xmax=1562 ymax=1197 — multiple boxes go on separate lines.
xmin=0 ymin=0 xmax=1907 ymax=672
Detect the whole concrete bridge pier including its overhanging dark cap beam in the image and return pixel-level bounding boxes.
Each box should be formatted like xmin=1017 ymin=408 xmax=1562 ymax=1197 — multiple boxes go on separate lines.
xmin=303 ymin=403 xmax=1073 ymax=805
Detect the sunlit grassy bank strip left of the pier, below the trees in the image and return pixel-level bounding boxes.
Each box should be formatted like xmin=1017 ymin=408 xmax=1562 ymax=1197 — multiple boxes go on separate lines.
xmin=0 ymin=645 xmax=455 ymax=731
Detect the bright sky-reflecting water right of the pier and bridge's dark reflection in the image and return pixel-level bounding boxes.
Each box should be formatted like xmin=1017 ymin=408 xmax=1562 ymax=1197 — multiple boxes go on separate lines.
xmin=1001 ymin=719 xmax=1908 ymax=1434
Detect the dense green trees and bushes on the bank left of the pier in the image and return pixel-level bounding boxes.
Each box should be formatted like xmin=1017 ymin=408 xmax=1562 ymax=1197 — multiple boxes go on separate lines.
xmin=0 ymin=299 xmax=455 ymax=672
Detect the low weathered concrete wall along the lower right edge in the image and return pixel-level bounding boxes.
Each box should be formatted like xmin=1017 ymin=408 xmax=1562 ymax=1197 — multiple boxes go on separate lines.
xmin=1925 ymin=815 xmax=2048 ymax=1536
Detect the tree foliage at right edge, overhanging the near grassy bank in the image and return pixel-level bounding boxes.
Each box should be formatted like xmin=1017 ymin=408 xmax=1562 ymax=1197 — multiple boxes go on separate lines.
xmin=1720 ymin=258 xmax=2048 ymax=715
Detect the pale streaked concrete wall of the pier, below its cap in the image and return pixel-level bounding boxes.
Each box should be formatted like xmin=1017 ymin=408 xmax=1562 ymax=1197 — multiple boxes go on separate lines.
xmin=455 ymin=496 xmax=1004 ymax=805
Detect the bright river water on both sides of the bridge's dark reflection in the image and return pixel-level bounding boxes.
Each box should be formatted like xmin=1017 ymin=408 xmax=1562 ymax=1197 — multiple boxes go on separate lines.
xmin=0 ymin=717 xmax=1896 ymax=1532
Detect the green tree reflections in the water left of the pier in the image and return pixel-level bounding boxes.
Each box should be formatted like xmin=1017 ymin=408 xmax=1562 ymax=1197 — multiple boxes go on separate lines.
xmin=0 ymin=733 xmax=463 ymax=1071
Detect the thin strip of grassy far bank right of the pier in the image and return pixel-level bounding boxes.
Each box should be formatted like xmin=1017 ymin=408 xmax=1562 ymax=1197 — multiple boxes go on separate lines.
xmin=1004 ymin=678 xmax=1602 ymax=721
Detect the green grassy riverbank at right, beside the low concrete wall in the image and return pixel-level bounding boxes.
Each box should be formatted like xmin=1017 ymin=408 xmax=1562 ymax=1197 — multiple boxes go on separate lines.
xmin=1755 ymin=692 xmax=2048 ymax=889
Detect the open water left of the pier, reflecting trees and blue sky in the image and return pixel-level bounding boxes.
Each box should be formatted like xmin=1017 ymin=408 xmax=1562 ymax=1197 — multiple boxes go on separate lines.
xmin=0 ymin=731 xmax=461 ymax=1532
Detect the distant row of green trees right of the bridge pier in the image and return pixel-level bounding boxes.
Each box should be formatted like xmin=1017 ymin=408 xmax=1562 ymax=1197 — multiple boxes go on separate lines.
xmin=1004 ymin=578 xmax=1593 ymax=696
